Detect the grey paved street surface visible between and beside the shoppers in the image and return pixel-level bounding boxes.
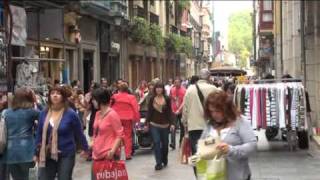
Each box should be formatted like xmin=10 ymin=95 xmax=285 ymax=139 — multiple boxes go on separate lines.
xmin=74 ymin=131 xmax=320 ymax=180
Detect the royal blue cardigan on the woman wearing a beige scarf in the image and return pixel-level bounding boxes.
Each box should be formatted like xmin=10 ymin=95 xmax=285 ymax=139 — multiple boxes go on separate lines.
xmin=35 ymin=108 xmax=88 ymax=157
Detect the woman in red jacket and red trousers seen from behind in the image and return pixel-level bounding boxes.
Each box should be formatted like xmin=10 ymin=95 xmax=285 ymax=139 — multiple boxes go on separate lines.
xmin=111 ymin=82 xmax=140 ymax=160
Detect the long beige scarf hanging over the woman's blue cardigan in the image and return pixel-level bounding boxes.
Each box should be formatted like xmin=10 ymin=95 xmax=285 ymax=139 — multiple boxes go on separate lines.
xmin=39 ymin=108 xmax=64 ymax=167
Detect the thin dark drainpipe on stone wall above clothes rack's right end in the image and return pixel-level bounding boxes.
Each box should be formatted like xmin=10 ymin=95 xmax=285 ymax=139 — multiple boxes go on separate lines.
xmin=300 ymin=1 xmax=307 ymax=87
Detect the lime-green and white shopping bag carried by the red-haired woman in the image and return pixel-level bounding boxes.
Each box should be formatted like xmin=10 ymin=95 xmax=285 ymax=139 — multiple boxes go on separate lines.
xmin=196 ymin=156 xmax=227 ymax=180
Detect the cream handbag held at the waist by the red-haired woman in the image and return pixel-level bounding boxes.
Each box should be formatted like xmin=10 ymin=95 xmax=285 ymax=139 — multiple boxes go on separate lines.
xmin=197 ymin=136 xmax=221 ymax=160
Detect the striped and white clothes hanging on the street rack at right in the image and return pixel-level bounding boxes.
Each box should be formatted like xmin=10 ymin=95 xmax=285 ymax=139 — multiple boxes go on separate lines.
xmin=234 ymin=82 xmax=307 ymax=130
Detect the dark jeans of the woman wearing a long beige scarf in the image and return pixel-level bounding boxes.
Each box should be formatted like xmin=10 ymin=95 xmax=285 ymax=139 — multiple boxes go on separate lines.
xmin=39 ymin=155 xmax=75 ymax=180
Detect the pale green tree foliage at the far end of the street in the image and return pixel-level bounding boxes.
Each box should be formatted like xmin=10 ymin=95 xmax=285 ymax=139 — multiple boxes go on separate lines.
xmin=228 ymin=10 xmax=252 ymax=67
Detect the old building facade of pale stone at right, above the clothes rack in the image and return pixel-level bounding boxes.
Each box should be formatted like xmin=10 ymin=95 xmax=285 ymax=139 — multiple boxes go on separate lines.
xmin=255 ymin=0 xmax=320 ymax=126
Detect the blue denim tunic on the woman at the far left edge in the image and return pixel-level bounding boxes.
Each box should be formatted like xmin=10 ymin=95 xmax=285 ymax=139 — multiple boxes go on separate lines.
xmin=0 ymin=108 xmax=39 ymax=164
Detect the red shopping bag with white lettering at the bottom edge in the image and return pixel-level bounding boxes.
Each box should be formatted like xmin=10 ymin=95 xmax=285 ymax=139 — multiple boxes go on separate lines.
xmin=93 ymin=160 xmax=128 ymax=180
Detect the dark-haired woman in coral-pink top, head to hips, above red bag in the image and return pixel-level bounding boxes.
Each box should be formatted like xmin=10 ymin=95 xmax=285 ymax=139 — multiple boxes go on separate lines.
xmin=92 ymin=88 xmax=124 ymax=160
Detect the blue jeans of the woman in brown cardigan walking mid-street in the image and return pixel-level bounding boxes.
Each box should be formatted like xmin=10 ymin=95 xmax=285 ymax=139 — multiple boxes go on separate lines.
xmin=150 ymin=125 xmax=169 ymax=165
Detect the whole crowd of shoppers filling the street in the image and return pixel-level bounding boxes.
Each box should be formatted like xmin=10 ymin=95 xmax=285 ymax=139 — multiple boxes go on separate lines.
xmin=5 ymin=69 xmax=310 ymax=180
